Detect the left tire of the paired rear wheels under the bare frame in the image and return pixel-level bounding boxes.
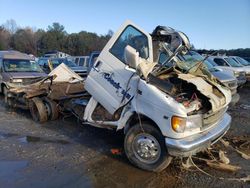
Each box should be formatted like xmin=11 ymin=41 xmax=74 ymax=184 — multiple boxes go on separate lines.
xmin=29 ymin=97 xmax=48 ymax=123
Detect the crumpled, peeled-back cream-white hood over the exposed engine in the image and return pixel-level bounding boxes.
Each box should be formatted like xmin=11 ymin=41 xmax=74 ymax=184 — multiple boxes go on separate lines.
xmin=137 ymin=60 xmax=231 ymax=112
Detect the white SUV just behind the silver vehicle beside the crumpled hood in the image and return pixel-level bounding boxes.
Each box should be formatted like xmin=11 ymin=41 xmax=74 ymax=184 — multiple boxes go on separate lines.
xmin=207 ymin=56 xmax=246 ymax=86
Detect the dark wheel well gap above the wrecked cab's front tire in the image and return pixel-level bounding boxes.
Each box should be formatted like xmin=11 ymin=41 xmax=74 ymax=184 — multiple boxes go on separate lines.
xmin=124 ymin=113 xmax=162 ymax=134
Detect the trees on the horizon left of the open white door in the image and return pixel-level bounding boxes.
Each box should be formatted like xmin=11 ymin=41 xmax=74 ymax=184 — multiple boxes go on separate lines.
xmin=0 ymin=20 xmax=113 ymax=56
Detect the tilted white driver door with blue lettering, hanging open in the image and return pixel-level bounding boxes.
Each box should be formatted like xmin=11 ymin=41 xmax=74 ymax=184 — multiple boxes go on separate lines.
xmin=85 ymin=22 xmax=153 ymax=114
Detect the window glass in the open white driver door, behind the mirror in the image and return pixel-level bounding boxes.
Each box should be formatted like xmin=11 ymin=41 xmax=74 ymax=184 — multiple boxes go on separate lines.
xmin=110 ymin=26 xmax=149 ymax=63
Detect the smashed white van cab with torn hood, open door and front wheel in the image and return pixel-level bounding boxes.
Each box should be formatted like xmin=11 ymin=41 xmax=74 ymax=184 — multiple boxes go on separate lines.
xmin=4 ymin=21 xmax=231 ymax=171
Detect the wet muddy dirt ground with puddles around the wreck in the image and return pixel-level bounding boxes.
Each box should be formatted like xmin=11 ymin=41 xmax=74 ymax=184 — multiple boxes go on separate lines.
xmin=0 ymin=88 xmax=250 ymax=188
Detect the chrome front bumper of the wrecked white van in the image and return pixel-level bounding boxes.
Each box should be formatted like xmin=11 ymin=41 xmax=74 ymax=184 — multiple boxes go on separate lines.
xmin=165 ymin=113 xmax=231 ymax=157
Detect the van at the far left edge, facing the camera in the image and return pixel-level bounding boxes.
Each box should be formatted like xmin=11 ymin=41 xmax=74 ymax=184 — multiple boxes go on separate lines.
xmin=0 ymin=50 xmax=47 ymax=102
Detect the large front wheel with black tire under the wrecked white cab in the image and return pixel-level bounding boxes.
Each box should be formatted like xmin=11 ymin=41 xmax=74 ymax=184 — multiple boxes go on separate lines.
xmin=124 ymin=122 xmax=172 ymax=172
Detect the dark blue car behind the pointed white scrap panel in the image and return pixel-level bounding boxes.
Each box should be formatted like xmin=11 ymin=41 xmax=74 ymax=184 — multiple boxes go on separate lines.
xmin=38 ymin=57 xmax=87 ymax=77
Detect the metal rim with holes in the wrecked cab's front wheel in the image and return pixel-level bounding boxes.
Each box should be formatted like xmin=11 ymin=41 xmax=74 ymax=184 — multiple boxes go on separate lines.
xmin=132 ymin=133 xmax=161 ymax=164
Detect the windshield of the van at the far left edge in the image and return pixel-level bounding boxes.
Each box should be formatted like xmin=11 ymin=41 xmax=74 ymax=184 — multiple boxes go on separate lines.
xmin=3 ymin=59 xmax=43 ymax=72
